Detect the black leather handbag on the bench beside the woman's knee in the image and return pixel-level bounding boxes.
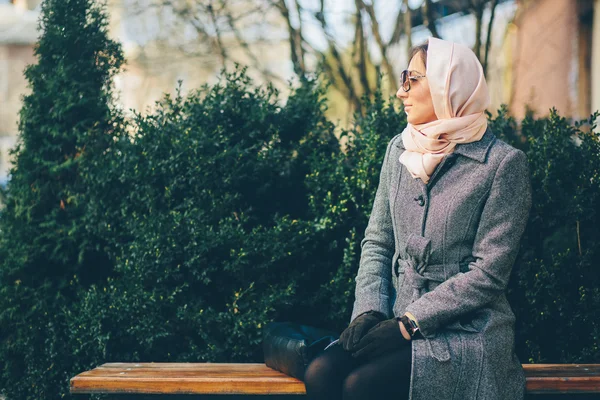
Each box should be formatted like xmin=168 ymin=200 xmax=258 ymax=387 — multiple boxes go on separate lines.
xmin=263 ymin=322 xmax=339 ymax=380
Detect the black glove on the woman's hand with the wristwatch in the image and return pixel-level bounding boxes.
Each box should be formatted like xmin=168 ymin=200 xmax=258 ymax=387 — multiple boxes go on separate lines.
xmin=352 ymin=318 xmax=410 ymax=360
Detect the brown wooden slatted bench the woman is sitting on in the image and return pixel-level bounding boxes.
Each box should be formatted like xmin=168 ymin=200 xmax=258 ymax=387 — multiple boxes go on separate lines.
xmin=70 ymin=363 xmax=600 ymax=399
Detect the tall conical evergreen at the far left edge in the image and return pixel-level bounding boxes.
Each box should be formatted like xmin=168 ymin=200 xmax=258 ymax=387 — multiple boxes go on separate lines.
xmin=0 ymin=0 xmax=123 ymax=400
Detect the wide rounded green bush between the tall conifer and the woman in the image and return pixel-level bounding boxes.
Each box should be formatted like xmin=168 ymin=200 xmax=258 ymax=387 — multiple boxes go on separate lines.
xmin=65 ymin=70 xmax=339 ymax=368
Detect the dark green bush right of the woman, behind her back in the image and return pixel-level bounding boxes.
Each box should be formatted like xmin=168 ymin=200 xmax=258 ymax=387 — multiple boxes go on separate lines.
xmin=502 ymin=110 xmax=600 ymax=363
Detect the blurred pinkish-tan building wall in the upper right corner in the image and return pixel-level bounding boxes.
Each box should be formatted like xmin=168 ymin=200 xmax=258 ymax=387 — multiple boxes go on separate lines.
xmin=505 ymin=0 xmax=600 ymax=119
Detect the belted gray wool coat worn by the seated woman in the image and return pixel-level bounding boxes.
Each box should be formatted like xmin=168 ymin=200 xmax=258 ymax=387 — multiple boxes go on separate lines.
xmin=351 ymin=128 xmax=531 ymax=400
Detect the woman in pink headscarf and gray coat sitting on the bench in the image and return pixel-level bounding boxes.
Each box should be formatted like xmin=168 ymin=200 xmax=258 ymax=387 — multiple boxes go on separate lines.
xmin=305 ymin=38 xmax=531 ymax=400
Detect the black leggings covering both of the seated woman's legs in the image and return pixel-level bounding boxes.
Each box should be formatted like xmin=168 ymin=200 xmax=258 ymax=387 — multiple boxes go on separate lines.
xmin=304 ymin=344 xmax=412 ymax=400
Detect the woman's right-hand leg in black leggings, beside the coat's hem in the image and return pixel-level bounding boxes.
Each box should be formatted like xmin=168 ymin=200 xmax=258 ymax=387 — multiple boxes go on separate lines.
xmin=342 ymin=345 xmax=412 ymax=400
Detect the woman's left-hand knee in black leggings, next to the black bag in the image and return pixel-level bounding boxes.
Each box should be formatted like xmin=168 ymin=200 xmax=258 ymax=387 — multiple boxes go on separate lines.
xmin=304 ymin=344 xmax=359 ymax=400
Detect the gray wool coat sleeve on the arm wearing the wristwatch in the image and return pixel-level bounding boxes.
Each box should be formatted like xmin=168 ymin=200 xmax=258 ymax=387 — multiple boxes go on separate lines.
xmin=406 ymin=149 xmax=531 ymax=338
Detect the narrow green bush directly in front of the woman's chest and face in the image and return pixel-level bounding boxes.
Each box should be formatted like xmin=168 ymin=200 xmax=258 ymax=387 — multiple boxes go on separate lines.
xmin=307 ymin=92 xmax=406 ymax=324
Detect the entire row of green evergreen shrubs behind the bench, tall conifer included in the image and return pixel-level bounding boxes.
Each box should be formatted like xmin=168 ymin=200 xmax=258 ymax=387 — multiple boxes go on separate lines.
xmin=0 ymin=0 xmax=600 ymax=400
